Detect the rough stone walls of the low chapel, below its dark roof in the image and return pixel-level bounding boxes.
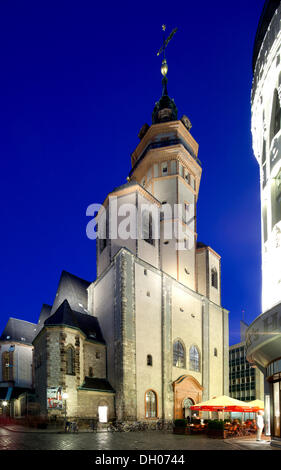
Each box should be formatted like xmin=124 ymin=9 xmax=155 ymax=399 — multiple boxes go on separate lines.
xmin=34 ymin=326 xmax=112 ymax=421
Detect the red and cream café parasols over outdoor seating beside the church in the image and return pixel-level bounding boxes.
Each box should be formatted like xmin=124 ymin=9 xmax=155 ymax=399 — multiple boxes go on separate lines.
xmin=190 ymin=395 xmax=254 ymax=413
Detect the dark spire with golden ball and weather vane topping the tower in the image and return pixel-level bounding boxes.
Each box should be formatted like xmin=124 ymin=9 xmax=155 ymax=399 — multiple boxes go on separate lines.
xmin=152 ymin=25 xmax=178 ymax=124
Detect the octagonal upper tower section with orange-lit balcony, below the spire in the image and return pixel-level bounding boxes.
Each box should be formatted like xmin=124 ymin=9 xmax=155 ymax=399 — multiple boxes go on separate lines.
xmin=130 ymin=115 xmax=202 ymax=290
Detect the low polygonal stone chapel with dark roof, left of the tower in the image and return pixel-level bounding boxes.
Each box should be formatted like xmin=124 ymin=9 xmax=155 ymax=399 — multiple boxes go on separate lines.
xmin=33 ymin=300 xmax=115 ymax=424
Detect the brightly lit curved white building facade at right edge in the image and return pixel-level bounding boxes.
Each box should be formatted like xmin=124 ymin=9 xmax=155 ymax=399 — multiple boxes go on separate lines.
xmin=247 ymin=0 xmax=281 ymax=444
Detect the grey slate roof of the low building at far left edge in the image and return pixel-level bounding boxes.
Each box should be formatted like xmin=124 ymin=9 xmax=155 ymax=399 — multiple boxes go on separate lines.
xmin=0 ymin=317 xmax=38 ymax=344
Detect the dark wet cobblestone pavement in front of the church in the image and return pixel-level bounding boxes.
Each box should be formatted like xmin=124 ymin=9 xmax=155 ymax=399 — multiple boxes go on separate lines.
xmin=0 ymin=428 xmax=276 ymax=450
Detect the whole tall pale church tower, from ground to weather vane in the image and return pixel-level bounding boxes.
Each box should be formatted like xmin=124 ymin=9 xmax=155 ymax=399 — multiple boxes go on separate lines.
xmin=88 ymin=30 xmax=229 ymax=426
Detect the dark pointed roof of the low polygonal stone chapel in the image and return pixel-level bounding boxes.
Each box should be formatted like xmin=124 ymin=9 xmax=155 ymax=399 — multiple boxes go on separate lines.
xmin=44 ymin=299 xmax=105 ymax=343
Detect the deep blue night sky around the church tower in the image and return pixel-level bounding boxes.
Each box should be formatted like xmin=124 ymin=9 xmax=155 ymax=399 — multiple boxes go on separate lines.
xmin=0 ymin=0 xmax=264 ymax=344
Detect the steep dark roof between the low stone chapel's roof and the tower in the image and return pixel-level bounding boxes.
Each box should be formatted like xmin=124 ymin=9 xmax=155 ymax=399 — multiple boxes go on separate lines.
xmin=51 ymin=271 xmax=91 ymax=315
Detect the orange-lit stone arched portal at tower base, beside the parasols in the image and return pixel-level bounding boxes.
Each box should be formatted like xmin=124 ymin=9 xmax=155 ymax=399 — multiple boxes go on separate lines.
xmin=173 ymin=375 xmax=203 ymax=419
